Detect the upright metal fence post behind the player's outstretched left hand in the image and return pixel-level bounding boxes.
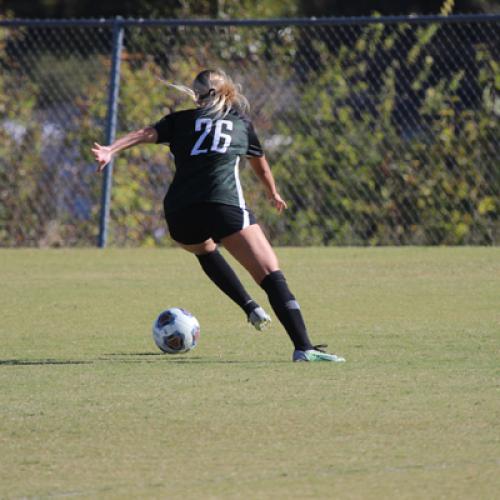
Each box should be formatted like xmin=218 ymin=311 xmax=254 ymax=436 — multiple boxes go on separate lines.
xmin=98 ymin=17 xmax=123 ymax=248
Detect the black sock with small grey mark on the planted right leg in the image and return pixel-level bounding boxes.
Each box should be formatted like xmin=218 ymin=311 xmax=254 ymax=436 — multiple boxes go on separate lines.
xmin=260 ymin=271 xmax=312 ymax=351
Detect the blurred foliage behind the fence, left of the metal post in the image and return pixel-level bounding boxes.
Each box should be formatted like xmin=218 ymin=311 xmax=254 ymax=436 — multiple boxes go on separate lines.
xmin=0 ymin=23 xmax=106 ymax=246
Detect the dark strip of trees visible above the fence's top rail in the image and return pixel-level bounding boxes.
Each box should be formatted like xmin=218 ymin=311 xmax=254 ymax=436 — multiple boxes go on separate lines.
xmin=0 ymin=0 xmax=499 ymax=19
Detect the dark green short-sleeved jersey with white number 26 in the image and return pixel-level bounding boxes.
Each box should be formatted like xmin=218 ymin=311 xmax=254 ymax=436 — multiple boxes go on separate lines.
xmin=153 ymin=109 xmax=263 ymax=213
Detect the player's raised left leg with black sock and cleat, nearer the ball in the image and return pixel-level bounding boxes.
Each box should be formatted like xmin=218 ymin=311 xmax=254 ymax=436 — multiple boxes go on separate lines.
xmin=180 ymin=239 xmax=271 ymax=331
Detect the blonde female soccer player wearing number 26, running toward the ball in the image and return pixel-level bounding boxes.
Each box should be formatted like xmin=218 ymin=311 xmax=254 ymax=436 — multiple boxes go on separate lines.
xmin=92 ymin=70 xmax=345 ymax=362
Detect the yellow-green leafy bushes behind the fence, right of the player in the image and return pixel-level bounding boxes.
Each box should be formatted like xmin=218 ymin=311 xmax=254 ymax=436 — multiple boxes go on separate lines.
xmin=269 ymin=24 xmax=500 ymax=245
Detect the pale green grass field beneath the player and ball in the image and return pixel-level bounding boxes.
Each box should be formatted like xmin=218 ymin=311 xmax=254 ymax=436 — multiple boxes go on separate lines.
xmin=0 ymin=248 xmax=500 ymax=499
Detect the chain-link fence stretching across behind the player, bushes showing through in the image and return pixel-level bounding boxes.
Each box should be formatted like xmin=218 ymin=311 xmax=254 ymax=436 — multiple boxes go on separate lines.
xmin=0 ymin=15 xmax=500 ymax=246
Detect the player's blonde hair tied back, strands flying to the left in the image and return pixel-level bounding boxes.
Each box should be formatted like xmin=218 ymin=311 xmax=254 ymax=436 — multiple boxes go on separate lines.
xmin=162 ymin=69 xmax=250 ymax=116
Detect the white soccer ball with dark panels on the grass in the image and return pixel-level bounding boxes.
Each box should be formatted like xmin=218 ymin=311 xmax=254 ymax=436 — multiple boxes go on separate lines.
xmin=153 ymin=307 xmax=200 ymax=354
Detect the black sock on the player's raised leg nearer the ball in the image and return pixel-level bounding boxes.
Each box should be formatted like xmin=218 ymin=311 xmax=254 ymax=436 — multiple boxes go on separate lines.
xmin=196 ymin=250 xmax=259 ymax=316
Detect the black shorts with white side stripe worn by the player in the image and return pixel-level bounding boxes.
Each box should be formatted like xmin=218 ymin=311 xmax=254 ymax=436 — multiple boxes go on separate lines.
xmin=165 ymin=203 xmax=256 ymax=245
